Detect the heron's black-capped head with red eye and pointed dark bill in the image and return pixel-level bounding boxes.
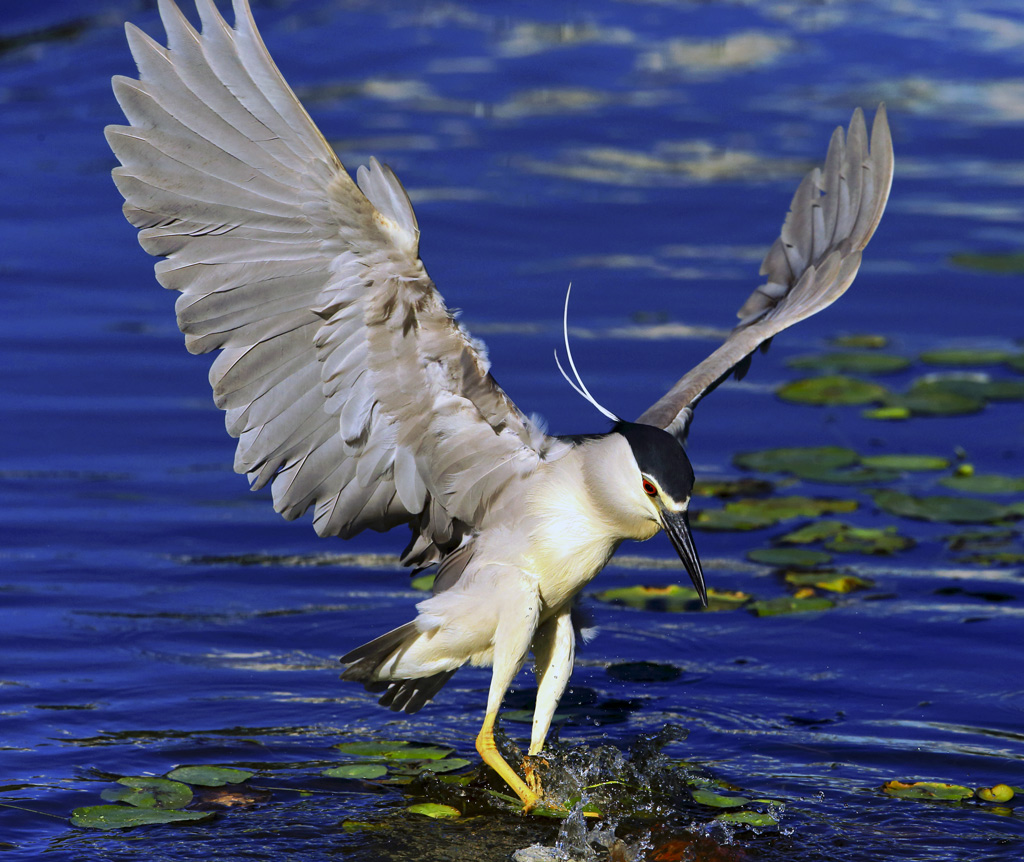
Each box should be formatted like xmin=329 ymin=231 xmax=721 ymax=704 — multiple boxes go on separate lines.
xmin=612 ymin=421 xmax=708 ymax=606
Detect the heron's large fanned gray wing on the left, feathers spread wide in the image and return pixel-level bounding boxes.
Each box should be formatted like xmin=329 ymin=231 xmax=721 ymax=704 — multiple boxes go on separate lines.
xmin=106 ymin=0 xmax=552 ymax=562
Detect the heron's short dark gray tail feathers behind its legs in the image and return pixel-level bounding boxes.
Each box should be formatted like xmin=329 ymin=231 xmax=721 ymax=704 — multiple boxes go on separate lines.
xmin=341 ymin=622 xmax=458 ymax=713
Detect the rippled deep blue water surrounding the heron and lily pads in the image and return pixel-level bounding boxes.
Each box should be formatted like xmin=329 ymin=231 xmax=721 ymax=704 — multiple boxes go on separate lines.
xmin=0 ymin=0 xmax=1024 ymax=860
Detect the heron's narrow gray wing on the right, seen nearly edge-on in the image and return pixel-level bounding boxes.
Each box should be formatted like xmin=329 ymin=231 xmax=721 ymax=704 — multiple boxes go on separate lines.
xmin=637 ymin=104 xmax=893 ymax=440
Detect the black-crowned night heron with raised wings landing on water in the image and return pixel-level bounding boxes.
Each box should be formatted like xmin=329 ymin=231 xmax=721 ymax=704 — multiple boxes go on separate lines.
xmin=105 ymin=0 xmax=893 ymax=811
